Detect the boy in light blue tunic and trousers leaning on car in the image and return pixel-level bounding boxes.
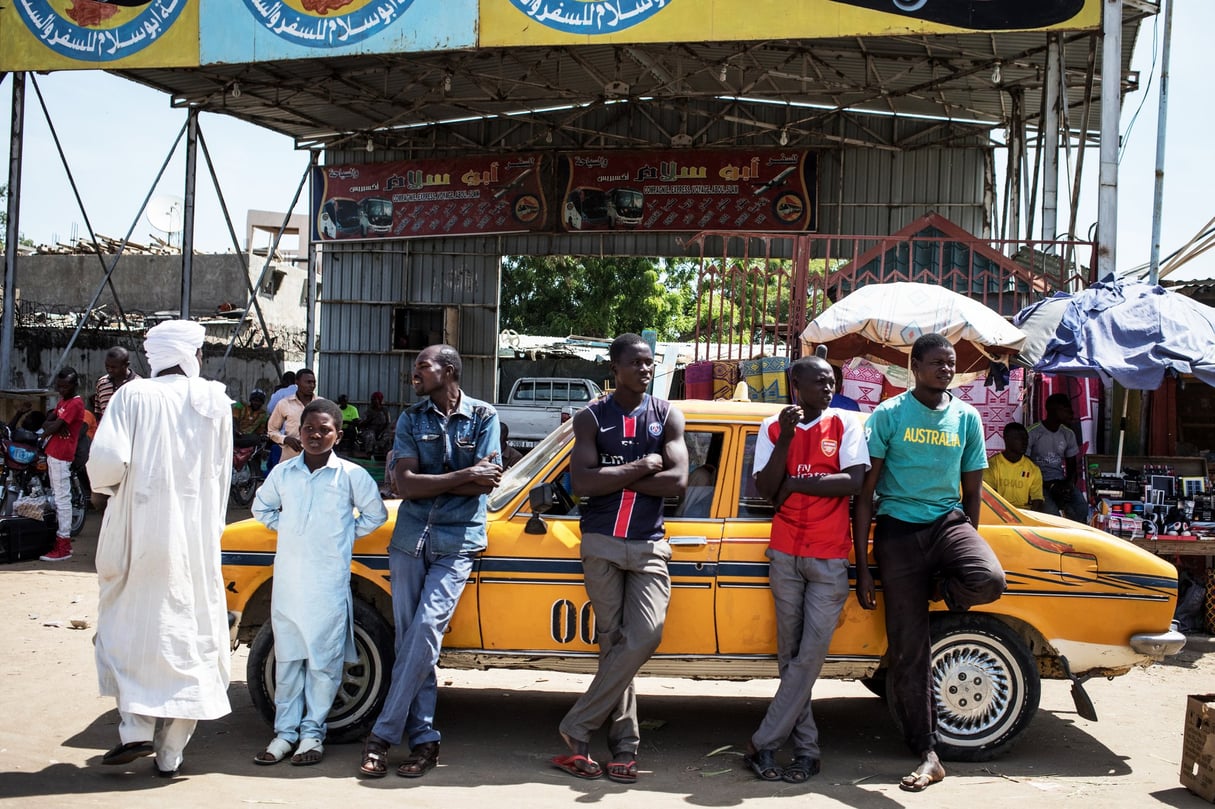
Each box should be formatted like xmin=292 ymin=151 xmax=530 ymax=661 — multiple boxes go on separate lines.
xmin=244 ymin=398 xmax=388 ymax=764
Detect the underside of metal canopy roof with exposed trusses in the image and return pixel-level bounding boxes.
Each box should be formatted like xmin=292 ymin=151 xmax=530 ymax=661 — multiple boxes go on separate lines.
xmin=109 ymin=2 xmax=1155 ymax=152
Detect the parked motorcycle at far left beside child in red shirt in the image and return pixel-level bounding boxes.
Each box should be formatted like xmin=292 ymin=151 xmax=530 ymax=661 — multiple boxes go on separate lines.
xmin=0 ymin=424 xmax=89 ymax=537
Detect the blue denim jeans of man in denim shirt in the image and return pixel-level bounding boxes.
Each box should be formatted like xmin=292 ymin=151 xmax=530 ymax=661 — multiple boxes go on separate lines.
xmin=372 ymin=544 xmax=473 ymax=748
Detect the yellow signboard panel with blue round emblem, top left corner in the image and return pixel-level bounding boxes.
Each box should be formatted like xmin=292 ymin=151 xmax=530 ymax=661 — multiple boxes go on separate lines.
xmin=0 ymin=0 xmax=200 ymax=70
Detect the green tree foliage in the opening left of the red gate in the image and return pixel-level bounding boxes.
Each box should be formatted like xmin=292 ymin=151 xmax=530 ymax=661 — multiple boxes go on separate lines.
xmin=499 ymin=256 xmax=695 ymax=340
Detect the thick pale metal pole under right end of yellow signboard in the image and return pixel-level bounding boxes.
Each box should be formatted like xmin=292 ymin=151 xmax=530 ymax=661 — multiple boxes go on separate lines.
xmin=1097 ymin=0 xmax=1123 ymax=279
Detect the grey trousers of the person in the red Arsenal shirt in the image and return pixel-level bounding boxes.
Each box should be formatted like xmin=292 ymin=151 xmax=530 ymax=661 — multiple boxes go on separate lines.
xmin=751 ymin=549 xmax=848 ymax=759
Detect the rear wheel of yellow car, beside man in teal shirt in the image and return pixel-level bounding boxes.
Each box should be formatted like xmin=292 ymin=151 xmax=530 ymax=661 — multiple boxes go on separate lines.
xmin=887 ymin=612 xmax=1041 ymax=762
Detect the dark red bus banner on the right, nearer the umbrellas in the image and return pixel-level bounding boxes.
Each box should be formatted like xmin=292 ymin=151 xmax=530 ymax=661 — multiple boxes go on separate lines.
xmin=558 ymin=148 xmax=816 ymax=232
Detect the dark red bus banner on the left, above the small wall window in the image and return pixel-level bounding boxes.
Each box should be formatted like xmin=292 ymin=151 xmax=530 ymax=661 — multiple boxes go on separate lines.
xmin=312 ymin=154 xmax=548 ymax=242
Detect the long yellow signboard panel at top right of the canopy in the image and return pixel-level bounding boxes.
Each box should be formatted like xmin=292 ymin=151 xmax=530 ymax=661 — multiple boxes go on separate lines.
xmin=480 ymin=0 xmax=1101 ymax=47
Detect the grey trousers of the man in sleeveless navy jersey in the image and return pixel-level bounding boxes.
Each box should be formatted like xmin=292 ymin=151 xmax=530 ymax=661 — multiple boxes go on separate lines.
xmin=561 ymin=533 xmax=671 ymax=754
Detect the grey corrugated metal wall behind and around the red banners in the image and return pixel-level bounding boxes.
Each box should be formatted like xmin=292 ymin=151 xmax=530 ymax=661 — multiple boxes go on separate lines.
xmin=317 ymin=108 xmax=991 ymax=403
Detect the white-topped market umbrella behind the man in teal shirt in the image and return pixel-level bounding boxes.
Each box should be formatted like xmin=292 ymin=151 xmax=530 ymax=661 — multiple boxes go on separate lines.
xmin=802 ymin=281 xmax=1025 ymax=374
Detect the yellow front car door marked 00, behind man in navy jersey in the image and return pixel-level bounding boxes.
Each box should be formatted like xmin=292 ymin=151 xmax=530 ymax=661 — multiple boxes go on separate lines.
xmin=476 ymin=428 xmax=730 ymax=655
